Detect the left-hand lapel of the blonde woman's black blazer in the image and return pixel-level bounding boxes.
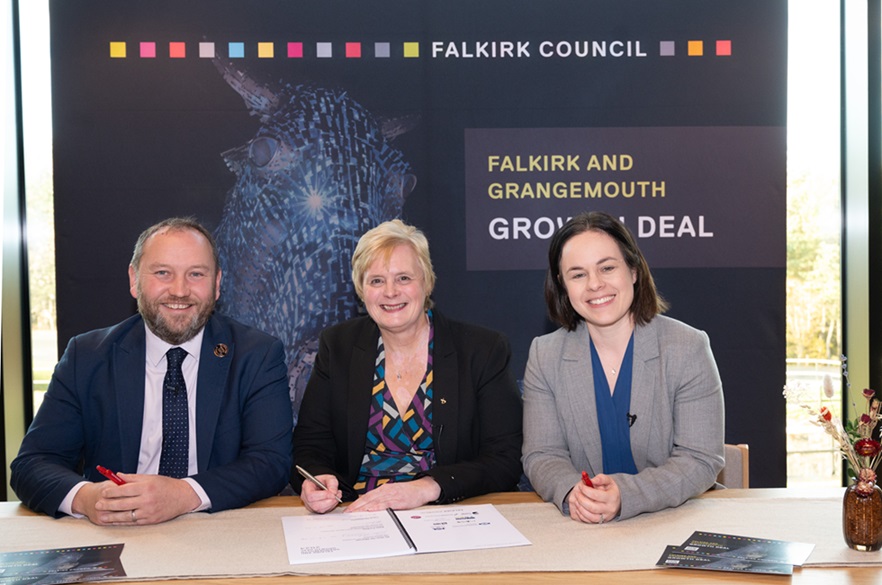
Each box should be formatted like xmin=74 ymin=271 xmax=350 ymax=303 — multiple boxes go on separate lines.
xmin=346 ymin=319 xmax=380 ymax=479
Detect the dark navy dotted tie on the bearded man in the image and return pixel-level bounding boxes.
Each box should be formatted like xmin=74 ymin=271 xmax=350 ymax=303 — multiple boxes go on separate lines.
xmin=159 ymin=347 xmax=190 ymax=478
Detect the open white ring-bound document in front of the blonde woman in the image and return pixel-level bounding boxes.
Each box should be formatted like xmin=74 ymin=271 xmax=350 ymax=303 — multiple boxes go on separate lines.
xmin=282 ymin=504 xmax=531 ymax=565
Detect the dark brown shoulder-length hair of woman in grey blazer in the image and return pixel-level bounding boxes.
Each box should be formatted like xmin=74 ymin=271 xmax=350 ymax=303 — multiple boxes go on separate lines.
xmin=545 ymin=211 xmax=668 ymax=331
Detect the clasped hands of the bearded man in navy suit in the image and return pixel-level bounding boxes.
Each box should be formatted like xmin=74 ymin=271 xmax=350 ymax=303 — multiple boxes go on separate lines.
xmin=71 ymin=473 xmax=202 ymax=526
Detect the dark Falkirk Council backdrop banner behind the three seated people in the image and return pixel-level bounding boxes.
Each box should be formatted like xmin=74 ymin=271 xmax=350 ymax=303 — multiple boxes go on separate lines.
xmin=50 ymin=0 xmax=787 ymax=487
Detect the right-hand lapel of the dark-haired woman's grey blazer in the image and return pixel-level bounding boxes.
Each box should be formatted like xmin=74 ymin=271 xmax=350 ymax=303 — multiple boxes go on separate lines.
xmin=629 ymin=321 xmax=661 ymax=469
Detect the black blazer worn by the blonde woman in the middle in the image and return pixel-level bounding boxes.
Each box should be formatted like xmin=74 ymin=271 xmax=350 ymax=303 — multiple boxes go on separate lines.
xmin=291 ymin=310 xmax=522 ymax=503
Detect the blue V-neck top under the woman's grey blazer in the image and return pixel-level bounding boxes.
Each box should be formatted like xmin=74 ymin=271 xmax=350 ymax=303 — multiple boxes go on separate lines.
xmin=591 ymin=333 xmax=637 ymax=475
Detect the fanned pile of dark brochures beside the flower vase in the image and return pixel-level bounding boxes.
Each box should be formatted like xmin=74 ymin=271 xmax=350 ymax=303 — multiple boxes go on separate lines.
xmin=656 ymin=531 xmax=815 ymax=575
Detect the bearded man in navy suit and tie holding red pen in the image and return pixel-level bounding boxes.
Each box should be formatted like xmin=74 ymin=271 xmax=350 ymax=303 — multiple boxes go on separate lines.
xmin=11 ymin=218 xmax=293 ymax=525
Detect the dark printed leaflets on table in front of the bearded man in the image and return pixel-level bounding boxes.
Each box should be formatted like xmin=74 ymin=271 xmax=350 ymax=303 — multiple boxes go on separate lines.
xmin=0 ymin=544 xmax=126 ymax=585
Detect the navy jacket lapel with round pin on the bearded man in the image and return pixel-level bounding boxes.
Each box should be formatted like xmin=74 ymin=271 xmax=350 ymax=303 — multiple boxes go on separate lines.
xmin=196 ymin=316 xmax=236 ymax=472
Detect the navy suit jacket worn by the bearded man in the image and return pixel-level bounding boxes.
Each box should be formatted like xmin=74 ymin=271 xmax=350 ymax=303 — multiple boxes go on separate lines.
xmin=11 ymin=314 xmax=293 ymax=516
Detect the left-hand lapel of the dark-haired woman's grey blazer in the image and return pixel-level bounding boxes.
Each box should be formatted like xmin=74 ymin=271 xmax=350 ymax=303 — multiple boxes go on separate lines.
xmin=561 ymin=322 xmax=603 ymax=475
